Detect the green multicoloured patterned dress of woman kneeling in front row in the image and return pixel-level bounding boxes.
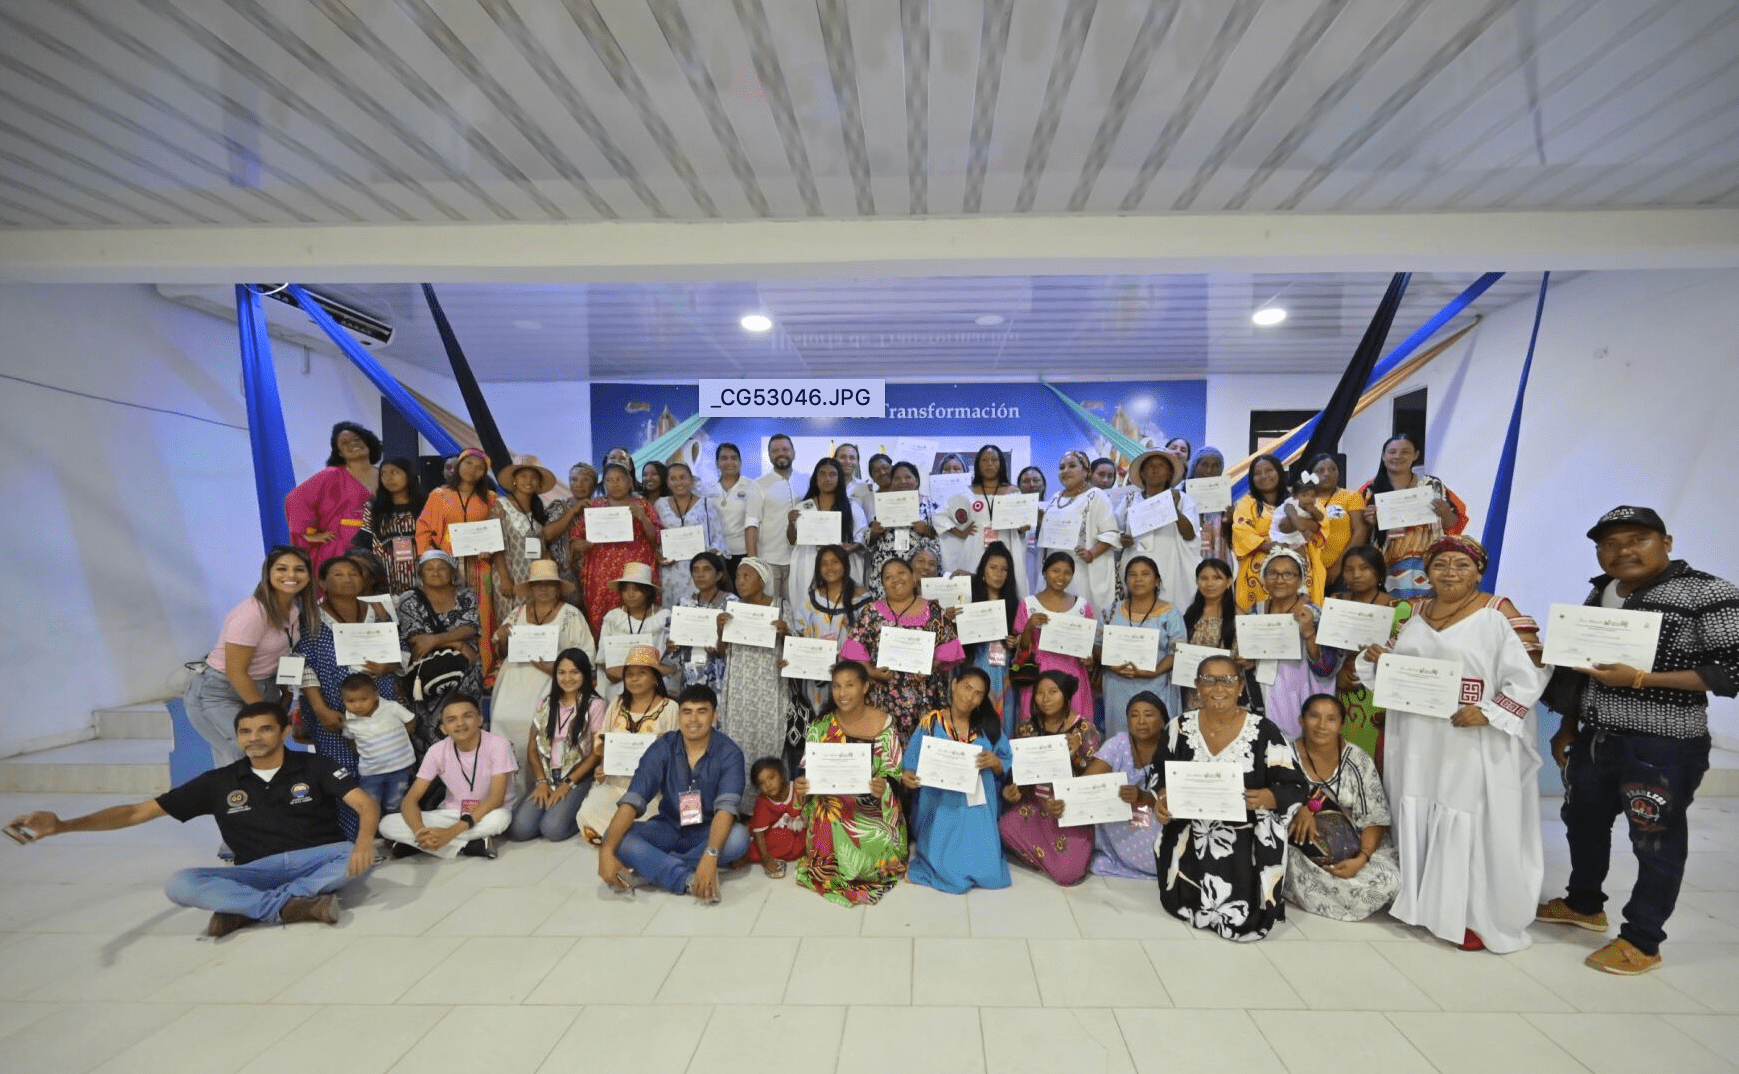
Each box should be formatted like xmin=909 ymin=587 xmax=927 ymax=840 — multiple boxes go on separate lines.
xmin=796 ymin=714 xmax=906 ymax=905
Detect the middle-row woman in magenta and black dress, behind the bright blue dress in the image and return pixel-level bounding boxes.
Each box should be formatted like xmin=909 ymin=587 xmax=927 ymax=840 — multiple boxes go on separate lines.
xmin=840 ymin=560 xmax=967 ymax=739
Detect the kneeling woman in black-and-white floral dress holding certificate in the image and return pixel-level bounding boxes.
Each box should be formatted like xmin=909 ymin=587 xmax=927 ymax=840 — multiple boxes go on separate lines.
xmin=1148 ymin=657 xmax=1306 ymax=940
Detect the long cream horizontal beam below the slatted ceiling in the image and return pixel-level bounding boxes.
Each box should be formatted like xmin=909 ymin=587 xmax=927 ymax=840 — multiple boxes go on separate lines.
xmin=0 ymin=209 xmax=1739 ymax=283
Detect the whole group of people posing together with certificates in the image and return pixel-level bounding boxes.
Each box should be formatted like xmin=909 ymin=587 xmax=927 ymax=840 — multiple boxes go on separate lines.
xmin=16 ymin=424 xmax=1739 ymax=973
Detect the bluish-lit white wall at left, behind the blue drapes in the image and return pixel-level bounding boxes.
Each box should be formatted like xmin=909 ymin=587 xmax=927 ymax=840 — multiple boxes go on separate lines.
xmin=0 ymin=285 xmax=459 ymax=756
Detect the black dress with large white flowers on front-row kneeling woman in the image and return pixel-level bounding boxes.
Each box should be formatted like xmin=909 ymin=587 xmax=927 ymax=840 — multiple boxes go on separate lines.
xmin=1148 ymin=711 xmax=1306 ymax=940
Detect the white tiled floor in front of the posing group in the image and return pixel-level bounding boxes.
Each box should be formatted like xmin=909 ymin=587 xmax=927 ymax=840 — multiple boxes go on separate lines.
xmin=0 ymin=796 xmax=1739 ymax=1074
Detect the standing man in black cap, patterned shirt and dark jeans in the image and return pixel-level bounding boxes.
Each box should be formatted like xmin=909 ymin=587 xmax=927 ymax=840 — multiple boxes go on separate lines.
xmin=1539 ymin=506 xmax=1739 ymax=975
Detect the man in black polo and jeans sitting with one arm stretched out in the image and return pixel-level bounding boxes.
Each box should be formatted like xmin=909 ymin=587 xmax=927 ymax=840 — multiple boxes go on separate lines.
xmin=7 ymin=700 xmax=381 ymax=938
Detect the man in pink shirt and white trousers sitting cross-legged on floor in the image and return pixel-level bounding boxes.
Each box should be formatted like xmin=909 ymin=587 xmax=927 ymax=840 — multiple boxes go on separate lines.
xmin=381 ymin=693 xmax=520 ymax=860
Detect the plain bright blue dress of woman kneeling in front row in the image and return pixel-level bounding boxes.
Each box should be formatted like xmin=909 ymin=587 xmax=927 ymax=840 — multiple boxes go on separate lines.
xmin=901 ymin=713 xmax=1014 ymax=895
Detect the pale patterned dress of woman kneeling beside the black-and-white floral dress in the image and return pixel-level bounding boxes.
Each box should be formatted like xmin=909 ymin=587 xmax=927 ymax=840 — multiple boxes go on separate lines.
xmin=1287 ymin=744 xmax=1402 ymax=921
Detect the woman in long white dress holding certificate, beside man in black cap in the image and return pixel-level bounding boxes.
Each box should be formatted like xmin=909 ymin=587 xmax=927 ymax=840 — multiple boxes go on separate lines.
xmin=1358 ymin=537 xmax=1546 ymax=954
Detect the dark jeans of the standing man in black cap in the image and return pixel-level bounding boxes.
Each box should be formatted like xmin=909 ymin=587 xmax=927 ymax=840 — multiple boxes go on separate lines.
xmin=1562 ymin=726 xmax=1709 ymax=954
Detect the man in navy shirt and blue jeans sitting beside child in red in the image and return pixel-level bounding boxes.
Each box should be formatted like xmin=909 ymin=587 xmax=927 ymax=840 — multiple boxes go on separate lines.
xmin=598 ymin=685 xmax=750 ymax=902
